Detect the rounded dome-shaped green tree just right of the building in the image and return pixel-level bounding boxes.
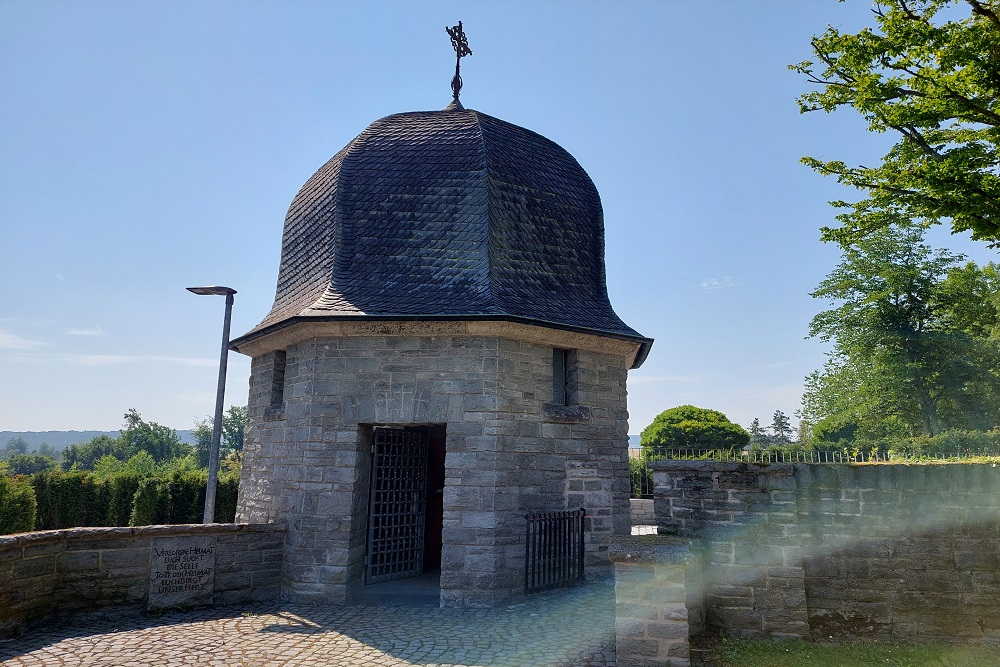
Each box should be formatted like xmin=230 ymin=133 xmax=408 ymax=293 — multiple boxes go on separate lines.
xmin=640 ymin=405 xmax=750 ymax=449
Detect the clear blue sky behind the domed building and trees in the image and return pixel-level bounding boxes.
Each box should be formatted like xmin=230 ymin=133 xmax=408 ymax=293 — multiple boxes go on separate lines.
xmin=0 ymin=0 xmax=995 ymax=433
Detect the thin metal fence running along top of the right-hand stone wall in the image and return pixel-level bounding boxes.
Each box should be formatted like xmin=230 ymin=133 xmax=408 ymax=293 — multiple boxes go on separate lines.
xmin=629 ymin=447 xmax=1000 ymax=498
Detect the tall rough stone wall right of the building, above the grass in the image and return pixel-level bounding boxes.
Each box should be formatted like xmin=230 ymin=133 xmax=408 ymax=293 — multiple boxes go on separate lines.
xmin=653 ymin=461 xmax=1000 ymax=641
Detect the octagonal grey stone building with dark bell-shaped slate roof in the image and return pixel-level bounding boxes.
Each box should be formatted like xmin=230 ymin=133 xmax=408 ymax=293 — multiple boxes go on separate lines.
xmin=232 ymin=100 xmax=652 ymax=606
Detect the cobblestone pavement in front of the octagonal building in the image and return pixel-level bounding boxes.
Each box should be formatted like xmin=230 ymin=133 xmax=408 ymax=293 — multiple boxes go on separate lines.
xmin=0 ymin=584 xmax=615 ymax=667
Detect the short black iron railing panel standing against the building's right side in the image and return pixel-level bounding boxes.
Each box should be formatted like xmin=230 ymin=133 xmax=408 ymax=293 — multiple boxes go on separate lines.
xmin=524 ymin=507 xmax=587 ymax=593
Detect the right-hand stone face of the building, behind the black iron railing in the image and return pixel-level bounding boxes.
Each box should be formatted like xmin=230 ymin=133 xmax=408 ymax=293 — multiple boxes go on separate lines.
xmin=489 ymin=339 xmax=631 ymax=590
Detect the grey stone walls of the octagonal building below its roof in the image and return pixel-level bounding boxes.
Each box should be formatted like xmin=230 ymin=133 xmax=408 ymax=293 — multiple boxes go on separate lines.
xmin=237 ymin=332 xmax=629 ymax=606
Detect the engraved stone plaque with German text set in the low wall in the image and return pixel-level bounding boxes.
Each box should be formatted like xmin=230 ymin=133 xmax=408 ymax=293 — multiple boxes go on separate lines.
xmin=146 ymin=535 xmax=215 ymax=609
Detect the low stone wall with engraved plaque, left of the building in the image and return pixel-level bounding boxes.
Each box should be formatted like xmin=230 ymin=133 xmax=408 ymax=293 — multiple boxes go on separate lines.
xmin=0 ymin=524 xmax=285 ymax=637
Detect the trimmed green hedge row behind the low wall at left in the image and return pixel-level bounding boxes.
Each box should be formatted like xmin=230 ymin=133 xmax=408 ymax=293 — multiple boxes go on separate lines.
xmin=0 ymin=470 xmax=239 ymax=535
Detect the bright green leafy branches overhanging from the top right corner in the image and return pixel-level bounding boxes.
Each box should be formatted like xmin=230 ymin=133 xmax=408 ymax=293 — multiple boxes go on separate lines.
xmin=790 ymin=0 xmax=1000 ymax=246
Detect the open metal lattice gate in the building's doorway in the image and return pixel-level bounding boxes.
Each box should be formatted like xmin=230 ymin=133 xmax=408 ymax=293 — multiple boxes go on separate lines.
xmin=365 ymin=428 xmax=427 ymax=584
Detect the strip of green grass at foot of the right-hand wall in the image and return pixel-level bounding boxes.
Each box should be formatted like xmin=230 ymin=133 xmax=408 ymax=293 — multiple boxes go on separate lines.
xmin=715 ymin=638 xmax=1000 ymax=667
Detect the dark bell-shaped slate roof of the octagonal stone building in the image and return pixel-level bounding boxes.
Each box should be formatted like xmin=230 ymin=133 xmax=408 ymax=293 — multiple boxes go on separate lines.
xmin=233 ymin=103 xmax=652 ymax=364
